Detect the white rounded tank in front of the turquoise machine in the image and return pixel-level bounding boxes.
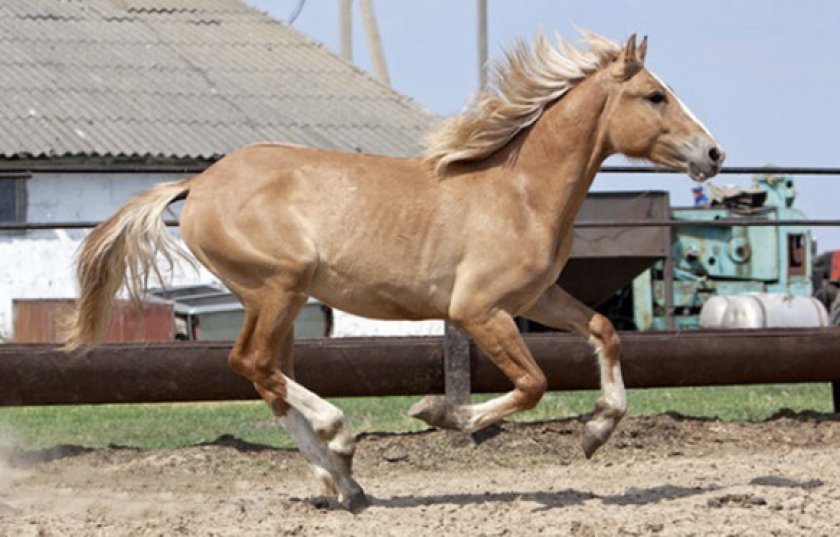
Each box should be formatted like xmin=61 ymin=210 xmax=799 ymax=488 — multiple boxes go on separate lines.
xmin=699 ymin=293 xmax=829 ymax=328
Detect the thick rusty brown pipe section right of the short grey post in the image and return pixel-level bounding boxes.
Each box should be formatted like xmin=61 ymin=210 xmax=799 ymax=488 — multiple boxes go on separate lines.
xmin=472 ymin=328 xmax=840 ymax=393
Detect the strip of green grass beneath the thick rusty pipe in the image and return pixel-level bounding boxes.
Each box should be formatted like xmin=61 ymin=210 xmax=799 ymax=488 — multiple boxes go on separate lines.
xmin=0 ymin=384 xmax=832 ymax=449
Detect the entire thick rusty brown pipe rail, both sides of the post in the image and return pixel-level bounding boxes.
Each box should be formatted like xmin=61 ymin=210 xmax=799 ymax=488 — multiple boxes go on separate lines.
xmin=0 ymin=328 xmax=840 ymax=406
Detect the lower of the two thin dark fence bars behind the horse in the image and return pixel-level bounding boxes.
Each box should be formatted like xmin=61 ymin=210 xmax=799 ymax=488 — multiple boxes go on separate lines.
xmin=0 ymin=218 xmax=840 ymax=231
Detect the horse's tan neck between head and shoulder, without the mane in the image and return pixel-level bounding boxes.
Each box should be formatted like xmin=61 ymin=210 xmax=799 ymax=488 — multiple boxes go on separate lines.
xmin=502 ymin=75 xmax=608 ymax=232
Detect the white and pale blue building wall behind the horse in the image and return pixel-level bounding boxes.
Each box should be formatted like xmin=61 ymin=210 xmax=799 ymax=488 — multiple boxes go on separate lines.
xmin=0 ymin=173 xmax=443 ymax=341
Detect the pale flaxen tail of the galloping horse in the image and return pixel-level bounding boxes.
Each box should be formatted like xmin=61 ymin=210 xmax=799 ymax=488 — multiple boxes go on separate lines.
xmin=64 ymin=179 xmax=193 ymax=350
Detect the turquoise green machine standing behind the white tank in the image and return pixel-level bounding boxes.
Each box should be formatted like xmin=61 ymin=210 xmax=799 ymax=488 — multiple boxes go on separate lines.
xmin=625 ymin=175 xmax=813 ymax=330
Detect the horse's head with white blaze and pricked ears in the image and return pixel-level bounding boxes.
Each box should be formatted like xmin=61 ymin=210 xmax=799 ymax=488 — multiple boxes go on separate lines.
xmin=606 ymin=35 xmax=725 ymax=181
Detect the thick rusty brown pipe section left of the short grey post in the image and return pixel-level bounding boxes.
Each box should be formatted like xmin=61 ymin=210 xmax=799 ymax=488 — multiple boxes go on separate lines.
xmin=0 ymin=338 xmax=443 ymax=406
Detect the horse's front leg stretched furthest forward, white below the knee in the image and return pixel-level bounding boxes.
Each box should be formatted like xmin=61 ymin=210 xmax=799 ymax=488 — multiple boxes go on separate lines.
xmin=523 ymin=285 xmax=627 ymax=458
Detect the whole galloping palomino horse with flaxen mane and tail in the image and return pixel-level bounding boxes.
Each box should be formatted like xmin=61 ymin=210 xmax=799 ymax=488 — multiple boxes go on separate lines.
xmin=67 ymin=34 xmax=724 ymax=510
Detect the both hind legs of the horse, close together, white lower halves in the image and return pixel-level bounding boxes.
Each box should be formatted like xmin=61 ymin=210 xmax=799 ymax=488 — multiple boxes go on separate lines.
xmin=230 ymin=289 xmax=367 ymax=511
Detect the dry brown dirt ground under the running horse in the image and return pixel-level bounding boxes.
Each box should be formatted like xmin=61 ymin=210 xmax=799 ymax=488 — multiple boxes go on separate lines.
xmin=0 ymin=414 xmax=840 ymax=537
